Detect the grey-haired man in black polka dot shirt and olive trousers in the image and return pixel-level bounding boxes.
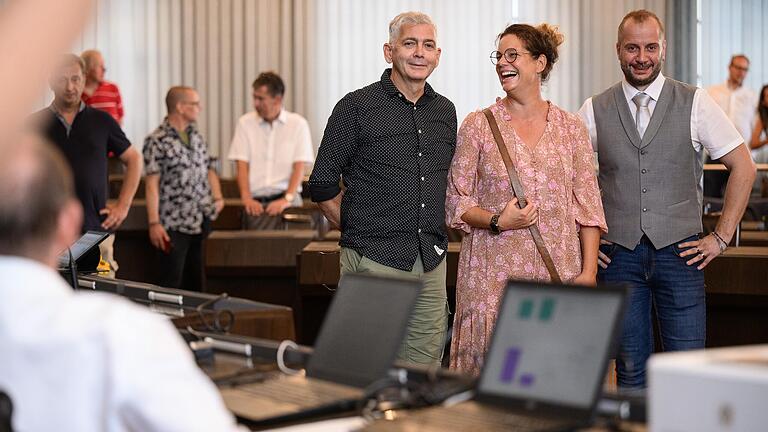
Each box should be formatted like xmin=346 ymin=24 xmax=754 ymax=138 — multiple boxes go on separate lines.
xmin=309 ymin=12 xmax=456 ymax=364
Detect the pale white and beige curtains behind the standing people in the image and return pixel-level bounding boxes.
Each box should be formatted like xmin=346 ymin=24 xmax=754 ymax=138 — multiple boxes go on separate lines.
xmin=15 ymin=0 xmax=676 ymax=176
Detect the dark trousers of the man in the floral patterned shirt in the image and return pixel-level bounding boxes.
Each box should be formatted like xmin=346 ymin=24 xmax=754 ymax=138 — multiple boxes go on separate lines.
xmin=157 ymin=224 xmax=209 ymax=292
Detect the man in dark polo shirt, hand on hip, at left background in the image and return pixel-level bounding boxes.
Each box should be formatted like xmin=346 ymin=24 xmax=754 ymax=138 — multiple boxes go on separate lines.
xmin=31 ymin=54 xmax=141 ymax=270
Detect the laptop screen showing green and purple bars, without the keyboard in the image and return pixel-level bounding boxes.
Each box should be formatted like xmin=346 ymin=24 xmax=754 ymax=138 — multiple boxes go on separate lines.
xmin=479 ymin=281 xmax=625 ymax=410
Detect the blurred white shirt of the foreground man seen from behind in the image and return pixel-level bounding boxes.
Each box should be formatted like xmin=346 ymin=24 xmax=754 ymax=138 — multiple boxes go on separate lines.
xmin=0 ymin=256 xmax=243 ymax=432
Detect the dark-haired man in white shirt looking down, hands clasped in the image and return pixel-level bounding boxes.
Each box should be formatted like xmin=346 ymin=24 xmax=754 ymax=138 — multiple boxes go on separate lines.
xmin=229 ymin=72 xmax=315 ymax=229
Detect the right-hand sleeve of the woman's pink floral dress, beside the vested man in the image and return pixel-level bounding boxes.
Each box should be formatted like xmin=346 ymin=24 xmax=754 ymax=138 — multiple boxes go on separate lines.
xmin=571 ymin=118 xmax=608 ymax=233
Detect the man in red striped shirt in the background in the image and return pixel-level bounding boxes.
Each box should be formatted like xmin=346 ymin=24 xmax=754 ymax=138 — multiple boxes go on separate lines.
xmin=80 ymin=50 xmax=123 ymax=126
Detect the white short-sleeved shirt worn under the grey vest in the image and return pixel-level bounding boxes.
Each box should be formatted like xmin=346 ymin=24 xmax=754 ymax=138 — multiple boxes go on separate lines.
xmin=578 ymin=74 xmax=744 ymax=159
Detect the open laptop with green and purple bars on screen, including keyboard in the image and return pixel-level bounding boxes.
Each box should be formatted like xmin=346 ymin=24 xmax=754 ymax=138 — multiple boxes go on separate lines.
xmin=366 ymin=281 xmax=627 ymax=432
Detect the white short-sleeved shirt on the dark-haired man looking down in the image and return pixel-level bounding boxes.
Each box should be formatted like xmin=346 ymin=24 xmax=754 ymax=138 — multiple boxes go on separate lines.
xmin=229 ymin=110 xmax=315 ymax=197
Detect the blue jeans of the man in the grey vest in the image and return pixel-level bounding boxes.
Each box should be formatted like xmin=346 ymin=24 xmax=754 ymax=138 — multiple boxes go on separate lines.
xmin=598 ymin=236 xmax=706 ymax=389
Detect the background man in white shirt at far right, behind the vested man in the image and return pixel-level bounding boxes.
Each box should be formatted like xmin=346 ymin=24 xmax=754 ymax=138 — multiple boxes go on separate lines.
xmin=704 ymin=54 xmax=768 ymax=197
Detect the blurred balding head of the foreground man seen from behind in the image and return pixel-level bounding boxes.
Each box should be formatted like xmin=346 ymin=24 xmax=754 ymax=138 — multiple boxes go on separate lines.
xmin=0 ymin=134 xmax=81 ymax=264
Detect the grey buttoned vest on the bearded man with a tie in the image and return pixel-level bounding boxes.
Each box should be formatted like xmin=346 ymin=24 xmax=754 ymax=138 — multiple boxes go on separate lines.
xmin=592 ymin=78 xmax=703 ymax=250
